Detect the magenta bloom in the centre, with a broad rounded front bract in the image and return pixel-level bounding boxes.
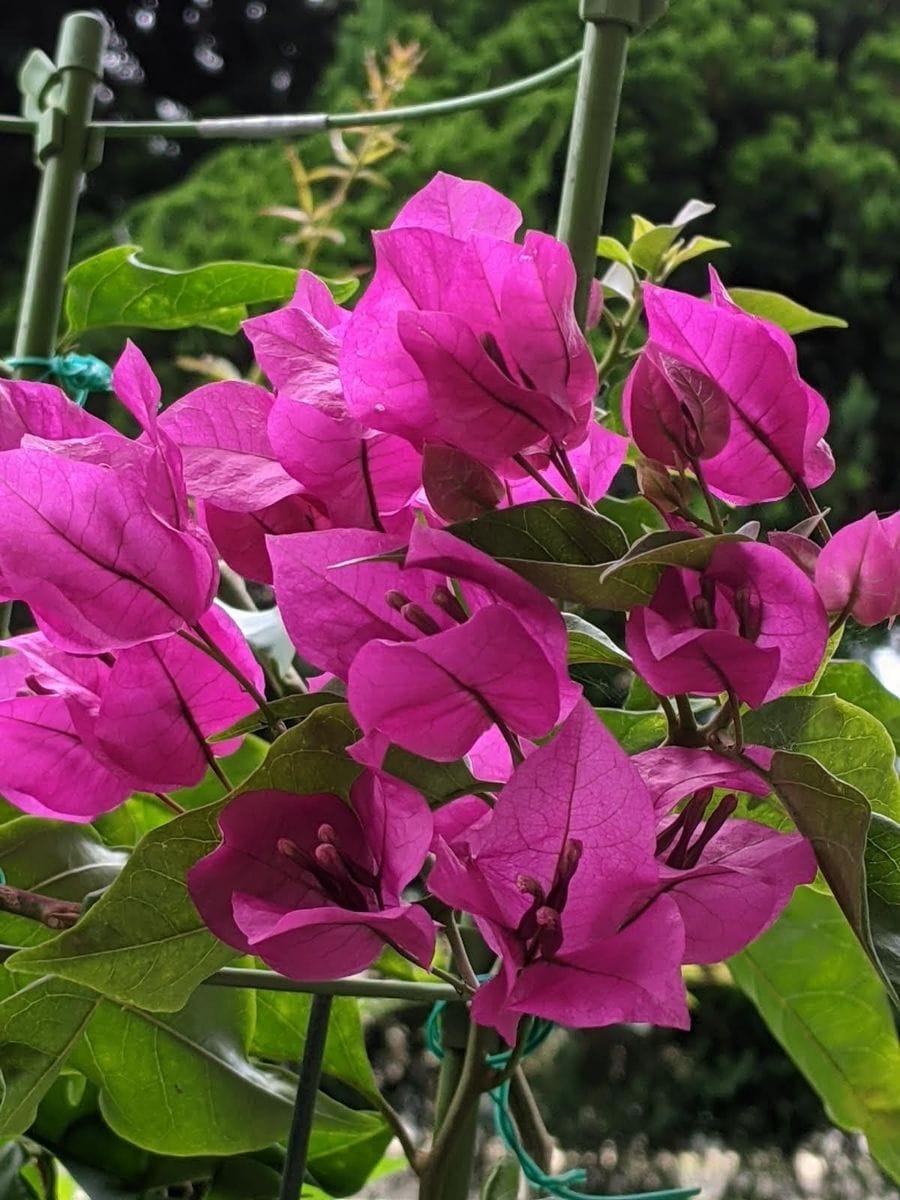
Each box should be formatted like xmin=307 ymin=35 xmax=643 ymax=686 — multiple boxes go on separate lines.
xmin=269 ymin=527 xmax=578 ymax=760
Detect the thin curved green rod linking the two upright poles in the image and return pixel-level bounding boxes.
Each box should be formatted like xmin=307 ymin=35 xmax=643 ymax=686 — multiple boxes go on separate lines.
xmin=0 ymin=50 xmax=582 ymax=140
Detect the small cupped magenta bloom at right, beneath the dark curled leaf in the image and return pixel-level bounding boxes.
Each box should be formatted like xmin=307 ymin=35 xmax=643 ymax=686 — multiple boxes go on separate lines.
xmin=625 ymin=542 xmax=828 ymax=708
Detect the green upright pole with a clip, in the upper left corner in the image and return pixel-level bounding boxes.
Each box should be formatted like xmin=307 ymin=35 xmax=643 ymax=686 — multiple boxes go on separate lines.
xmin=14 ymin=12 xmax=108 ymax=358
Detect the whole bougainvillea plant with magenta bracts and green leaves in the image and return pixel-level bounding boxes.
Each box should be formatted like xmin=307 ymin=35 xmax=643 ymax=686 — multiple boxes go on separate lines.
xmin=0 ymin=175 xmax=900 ymax=1200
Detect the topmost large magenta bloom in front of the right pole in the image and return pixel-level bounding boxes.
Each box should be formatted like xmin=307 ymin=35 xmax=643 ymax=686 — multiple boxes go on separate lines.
xmin=340 ymin=175 xmax=596 ymax=466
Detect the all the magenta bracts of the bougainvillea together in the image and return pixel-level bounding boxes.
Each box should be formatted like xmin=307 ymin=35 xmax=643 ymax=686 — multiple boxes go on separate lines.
xmin=0 ymin=175 xmax=900 ymax=1039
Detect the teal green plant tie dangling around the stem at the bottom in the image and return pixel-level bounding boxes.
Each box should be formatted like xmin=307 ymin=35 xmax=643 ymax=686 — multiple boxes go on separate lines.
xmin=425 ymin=1001 xmax=700 ymax=1200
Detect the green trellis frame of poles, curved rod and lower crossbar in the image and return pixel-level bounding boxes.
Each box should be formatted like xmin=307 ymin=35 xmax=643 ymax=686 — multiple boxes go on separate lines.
xmin=0 ymin=0 xmax=666 ymax=1200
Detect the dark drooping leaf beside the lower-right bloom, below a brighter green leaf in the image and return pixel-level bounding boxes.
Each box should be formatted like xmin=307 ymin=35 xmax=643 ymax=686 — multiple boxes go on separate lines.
xmin=768 ymin=750 xmax=871 ymax=949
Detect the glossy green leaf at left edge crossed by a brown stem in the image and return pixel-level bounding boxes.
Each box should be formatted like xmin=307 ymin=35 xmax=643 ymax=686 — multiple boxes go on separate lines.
xmin=0 ymin=817 xmax=126 ymax=946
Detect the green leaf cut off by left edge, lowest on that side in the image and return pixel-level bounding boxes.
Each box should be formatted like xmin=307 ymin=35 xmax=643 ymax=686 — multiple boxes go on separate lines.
xmin=0 ymin=979 xmax=96 ymax=1138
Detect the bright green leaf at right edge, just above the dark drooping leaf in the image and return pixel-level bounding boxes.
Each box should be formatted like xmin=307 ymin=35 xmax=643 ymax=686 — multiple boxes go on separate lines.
xmin=744 ymin=696 xmax=900 ymax=820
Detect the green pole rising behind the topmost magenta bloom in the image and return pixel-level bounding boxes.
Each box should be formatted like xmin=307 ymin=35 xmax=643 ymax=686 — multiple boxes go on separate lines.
xmin=557 ymin=0 xmax=665 ymax=325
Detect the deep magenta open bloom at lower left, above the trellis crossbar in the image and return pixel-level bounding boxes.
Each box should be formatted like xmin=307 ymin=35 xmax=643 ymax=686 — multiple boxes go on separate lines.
xmin=188 ymin=770 xmax=434 ymax=980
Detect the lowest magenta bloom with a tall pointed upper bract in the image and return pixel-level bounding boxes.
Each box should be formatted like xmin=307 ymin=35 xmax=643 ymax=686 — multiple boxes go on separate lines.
xmin=428 ymin=701 xmax=688 ymax=1043
